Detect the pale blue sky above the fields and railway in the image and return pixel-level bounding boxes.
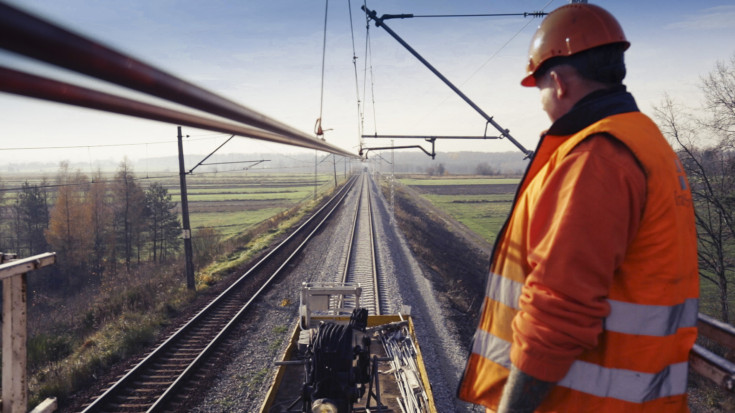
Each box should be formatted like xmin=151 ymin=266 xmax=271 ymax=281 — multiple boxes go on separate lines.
xmin=0 ymin=0 xmax=735 ymax=165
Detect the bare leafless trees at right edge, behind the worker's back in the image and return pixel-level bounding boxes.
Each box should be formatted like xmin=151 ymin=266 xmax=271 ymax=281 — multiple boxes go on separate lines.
xmin=656 ymin=55 xmax=735 ymax=322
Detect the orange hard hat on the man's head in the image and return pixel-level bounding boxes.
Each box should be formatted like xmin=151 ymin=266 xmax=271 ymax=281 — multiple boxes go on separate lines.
xmin=521 ymin=3 xmax=630 ymax=86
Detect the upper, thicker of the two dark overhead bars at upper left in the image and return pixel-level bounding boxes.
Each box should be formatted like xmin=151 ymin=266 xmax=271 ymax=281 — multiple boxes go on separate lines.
xmin=0 ymin=2 xmax=355 ymax=156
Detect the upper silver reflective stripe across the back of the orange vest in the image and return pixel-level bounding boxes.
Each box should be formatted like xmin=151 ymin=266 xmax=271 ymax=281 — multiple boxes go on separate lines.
xmin=604 ymin=298 xmax=699 ymax=337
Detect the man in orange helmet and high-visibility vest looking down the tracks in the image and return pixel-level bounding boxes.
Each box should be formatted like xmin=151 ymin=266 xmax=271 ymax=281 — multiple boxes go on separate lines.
xmin=459 ymin=4 xmax=699 ymax=413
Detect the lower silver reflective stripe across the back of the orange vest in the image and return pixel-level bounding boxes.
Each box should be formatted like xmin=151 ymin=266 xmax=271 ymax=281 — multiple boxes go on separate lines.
xmin=557 ymin=360 xmax=688 ymax=403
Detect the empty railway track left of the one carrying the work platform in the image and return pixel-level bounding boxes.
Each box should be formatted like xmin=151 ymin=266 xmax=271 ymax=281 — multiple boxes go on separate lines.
xmin=83 ymin=177 xmax=357 ymax=412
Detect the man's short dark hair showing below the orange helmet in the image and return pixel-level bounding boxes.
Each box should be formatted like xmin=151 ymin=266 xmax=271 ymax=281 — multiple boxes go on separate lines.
xmin=534 ymin=43 xmax=625 ymax=86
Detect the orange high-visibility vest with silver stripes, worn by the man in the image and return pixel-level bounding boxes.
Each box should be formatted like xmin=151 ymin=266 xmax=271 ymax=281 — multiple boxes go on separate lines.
xmin=459 ymin=112 xmax=699 ymax=413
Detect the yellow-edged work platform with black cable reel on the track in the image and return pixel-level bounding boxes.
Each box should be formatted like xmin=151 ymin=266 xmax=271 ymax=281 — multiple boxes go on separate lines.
xmin=261 ymin=283 xmax=436 ymax=413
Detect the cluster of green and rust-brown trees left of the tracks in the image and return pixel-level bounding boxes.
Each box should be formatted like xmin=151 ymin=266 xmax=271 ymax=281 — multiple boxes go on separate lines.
xmin=0 ymin=160 xmax=181 ymax=286
